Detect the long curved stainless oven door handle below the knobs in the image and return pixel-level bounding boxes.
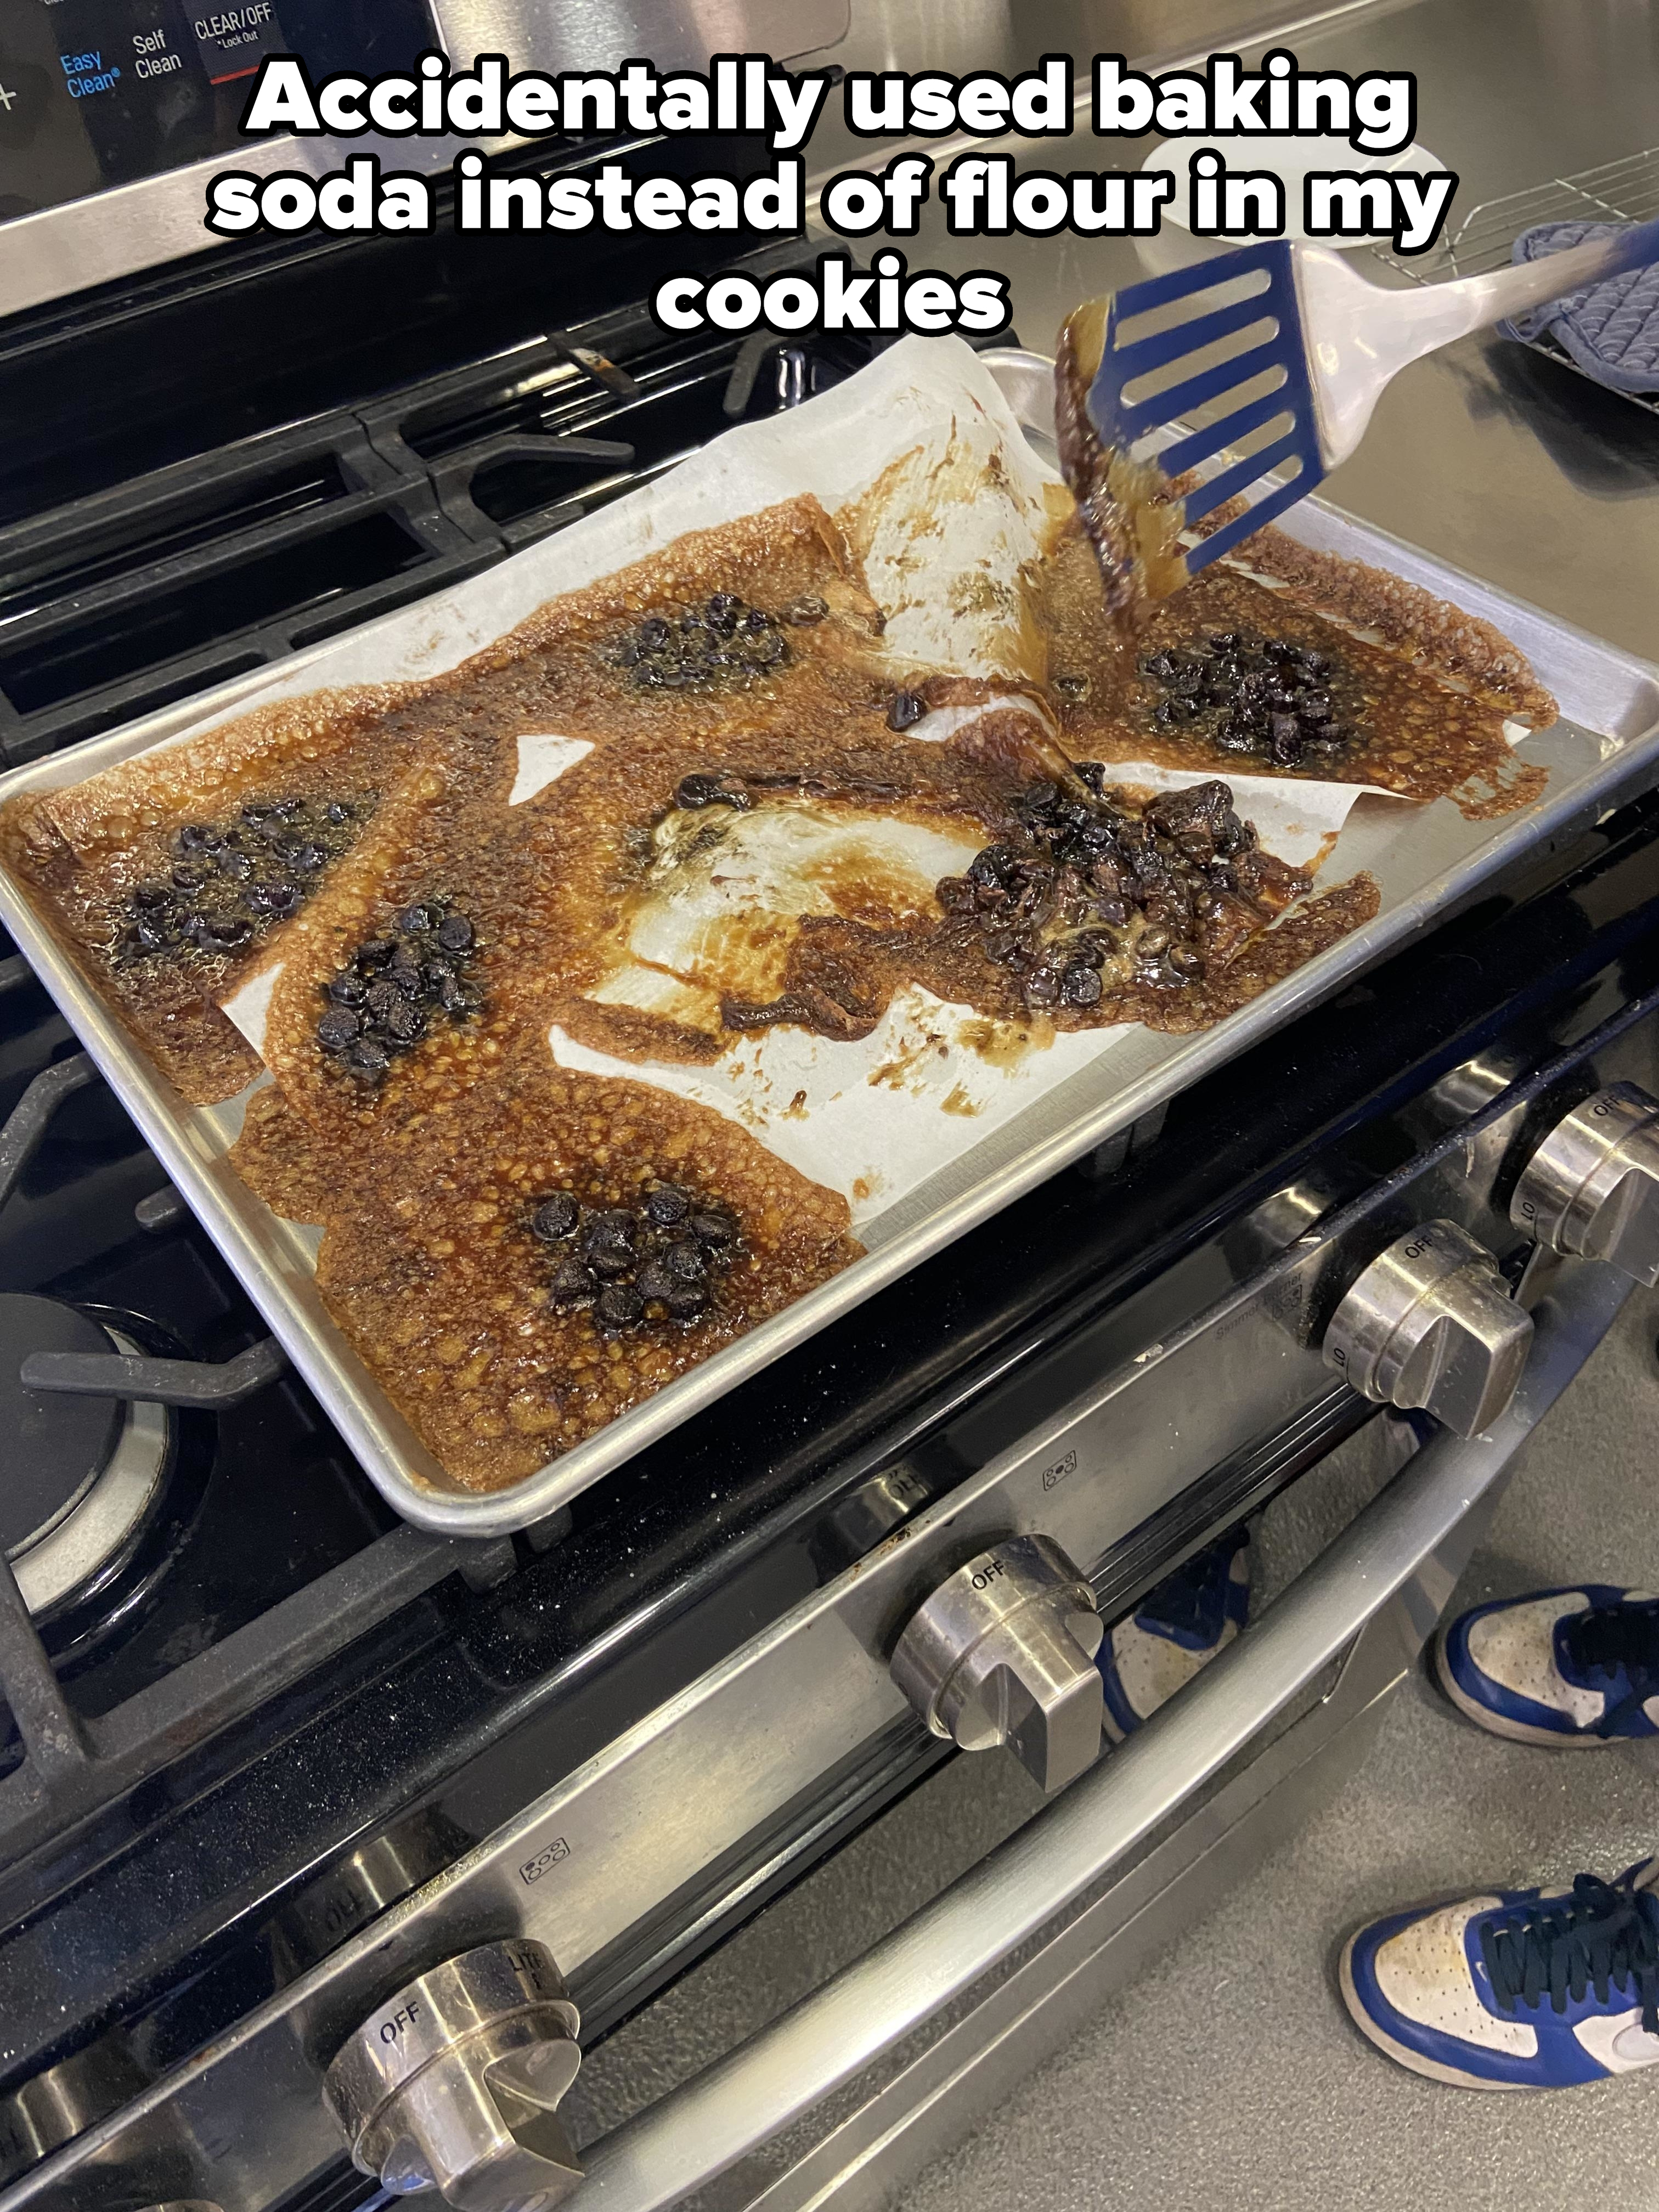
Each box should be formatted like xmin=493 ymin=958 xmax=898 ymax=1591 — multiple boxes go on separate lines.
xmin=577 ymin=1261 xmax=1630 ymax=2212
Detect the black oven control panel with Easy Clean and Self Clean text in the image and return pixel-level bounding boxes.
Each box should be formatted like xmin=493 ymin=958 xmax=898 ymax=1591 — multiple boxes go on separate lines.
xmin=0 ymin=0 xmax=436 ymax=221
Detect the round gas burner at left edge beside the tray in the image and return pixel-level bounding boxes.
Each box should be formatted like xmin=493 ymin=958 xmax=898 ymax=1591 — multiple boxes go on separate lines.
xmin=0 ymin=1292 xmax=210 ymax=1659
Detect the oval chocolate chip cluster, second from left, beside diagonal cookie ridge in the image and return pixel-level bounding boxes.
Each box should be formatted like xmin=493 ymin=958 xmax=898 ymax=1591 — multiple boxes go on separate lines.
xmin=317 ymin=898 xmax=484 ymax=1084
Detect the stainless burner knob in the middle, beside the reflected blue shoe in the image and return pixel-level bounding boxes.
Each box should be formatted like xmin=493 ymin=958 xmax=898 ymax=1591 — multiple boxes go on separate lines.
xmin=894 ymin=1535 xmax=1106 ymax=1790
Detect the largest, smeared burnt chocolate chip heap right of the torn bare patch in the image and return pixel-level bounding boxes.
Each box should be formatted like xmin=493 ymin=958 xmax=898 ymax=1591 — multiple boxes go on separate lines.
xmin=938 ymin=761 xmax=1256 ymax=1009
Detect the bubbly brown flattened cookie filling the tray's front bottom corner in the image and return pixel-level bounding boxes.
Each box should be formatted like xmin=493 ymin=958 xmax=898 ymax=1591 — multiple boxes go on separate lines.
xmin=234 ymin=1055 xmax=860 ymax=1491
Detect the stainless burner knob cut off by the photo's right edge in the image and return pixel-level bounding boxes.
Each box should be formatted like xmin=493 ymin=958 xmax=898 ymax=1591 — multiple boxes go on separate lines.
xmin=1509 ymin=1084 xmax=1659 ymax=1283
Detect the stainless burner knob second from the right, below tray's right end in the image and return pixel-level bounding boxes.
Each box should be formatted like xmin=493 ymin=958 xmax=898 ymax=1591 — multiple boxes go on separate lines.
xmin=1325 ymin=1221 xmax=1533 ymax=1436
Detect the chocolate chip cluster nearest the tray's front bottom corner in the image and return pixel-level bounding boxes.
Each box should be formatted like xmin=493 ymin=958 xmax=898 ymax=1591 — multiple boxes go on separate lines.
xmin=529 ymin=1183 xmax=739 ymax=1334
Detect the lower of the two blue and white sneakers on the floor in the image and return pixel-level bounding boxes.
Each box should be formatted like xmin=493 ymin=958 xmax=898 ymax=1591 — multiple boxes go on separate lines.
xmin=1342 ymin=1858 xmax=1659 ymax=2088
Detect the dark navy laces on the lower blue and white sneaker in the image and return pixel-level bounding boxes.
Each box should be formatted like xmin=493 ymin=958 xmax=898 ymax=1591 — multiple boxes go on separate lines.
xmin=1480 ymin=1874 xmax=1659 ymax=2035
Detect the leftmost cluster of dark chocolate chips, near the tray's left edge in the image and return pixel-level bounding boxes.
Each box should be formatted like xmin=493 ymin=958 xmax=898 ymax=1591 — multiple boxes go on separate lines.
xmin=111 ymin=792 xmax=374 ymax=967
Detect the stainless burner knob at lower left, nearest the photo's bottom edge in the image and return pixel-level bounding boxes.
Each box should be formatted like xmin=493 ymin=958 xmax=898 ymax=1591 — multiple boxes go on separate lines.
xmin=323 ymin=1940 xmax=582 ymax=2212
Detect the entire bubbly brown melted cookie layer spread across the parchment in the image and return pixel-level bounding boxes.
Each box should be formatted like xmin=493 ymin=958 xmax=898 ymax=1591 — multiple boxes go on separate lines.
xmin=16 ymin=473 xmax=1575 ymax=1489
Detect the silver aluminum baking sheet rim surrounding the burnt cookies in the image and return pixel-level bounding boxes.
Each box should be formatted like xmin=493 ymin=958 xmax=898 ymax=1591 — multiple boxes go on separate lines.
xmin=0 ymin=352 xmax=1659 ymax=1535
